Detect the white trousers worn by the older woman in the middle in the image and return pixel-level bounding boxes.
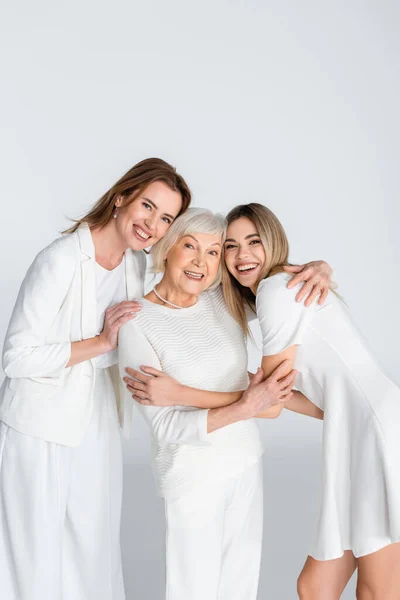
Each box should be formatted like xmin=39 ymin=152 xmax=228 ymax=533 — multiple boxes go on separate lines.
xmin=165 ymin=460 xmax=263 ymax=600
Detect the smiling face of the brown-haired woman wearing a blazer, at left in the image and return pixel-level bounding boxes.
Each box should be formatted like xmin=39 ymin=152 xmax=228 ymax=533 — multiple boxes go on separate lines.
xmin=115 ymin=181 xmax=182 ymax=250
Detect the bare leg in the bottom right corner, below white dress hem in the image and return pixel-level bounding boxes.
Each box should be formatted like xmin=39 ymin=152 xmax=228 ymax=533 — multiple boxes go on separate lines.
xmin=357 ymin=543 xmax=400 ymax=600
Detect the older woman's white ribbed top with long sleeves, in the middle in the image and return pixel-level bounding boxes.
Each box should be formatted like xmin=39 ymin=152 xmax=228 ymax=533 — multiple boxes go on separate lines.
xmin=119 ymin=289 xmax=263 ymax=497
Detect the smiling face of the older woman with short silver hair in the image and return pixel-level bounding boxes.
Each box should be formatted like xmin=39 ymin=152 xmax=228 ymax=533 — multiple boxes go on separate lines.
xmin=163 ymin=233 xmax=222 ymax=296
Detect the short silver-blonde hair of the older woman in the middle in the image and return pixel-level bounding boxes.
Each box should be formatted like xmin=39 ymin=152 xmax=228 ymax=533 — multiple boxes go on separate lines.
xmin=150 ymin=208 xmax=226 ymax=287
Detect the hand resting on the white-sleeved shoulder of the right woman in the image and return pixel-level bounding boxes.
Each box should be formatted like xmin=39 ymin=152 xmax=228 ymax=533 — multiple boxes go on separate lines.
xmin=283 ymin=260 xmax=332 ymax=306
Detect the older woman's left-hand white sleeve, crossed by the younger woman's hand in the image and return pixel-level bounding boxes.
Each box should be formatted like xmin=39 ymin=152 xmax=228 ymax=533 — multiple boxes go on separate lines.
xmin=118 ymin=321 xmax=209 ymax=445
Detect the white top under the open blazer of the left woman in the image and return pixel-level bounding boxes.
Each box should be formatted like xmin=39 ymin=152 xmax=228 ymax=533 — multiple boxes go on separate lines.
xmin=94 ymin=258 xmax=126 ymax=369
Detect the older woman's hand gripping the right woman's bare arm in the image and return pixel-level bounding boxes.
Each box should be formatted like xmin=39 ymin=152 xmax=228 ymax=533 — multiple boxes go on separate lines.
xmin=238 ymin=360 xmax=297 ymax=419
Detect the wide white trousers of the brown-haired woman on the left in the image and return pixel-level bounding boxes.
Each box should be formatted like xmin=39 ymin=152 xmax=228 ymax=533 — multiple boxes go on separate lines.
xmin=0 ymin=370 xmax=125 ymax=600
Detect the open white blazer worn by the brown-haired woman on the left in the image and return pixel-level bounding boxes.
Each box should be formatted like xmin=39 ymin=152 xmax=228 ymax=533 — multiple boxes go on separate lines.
xmin=0 ymin=224 xmax=146 ymax=446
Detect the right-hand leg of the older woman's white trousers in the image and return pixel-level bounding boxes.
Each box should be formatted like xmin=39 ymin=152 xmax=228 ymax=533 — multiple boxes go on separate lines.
xmin=218 ymin=460 xmax=263 ymax=600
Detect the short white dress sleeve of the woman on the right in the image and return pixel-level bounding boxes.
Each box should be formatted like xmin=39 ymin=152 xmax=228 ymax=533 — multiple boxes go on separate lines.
xmin=256 ymin=273 xmax=318 ymax=356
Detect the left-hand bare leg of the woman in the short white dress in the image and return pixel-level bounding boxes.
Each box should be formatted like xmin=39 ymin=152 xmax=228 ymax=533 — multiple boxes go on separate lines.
xmin=297 ymin=550 xmax=357 ymax=600
